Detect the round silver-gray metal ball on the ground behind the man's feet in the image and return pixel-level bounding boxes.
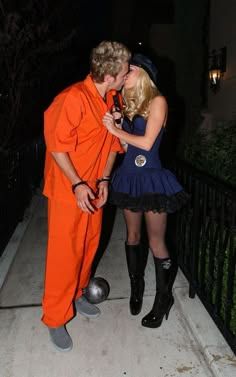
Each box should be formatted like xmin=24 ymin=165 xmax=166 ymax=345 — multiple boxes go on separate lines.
xmin=84 ymin=277 xmax=110 ymax=304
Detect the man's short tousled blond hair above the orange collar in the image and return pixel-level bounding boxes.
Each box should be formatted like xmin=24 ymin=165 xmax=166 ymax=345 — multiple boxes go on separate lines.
xmin=90 ymin=41 xmax=131 ymax=83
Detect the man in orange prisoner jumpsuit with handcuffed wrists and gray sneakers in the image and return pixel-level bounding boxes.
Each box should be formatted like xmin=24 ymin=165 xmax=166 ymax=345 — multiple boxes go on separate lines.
xmin=42 ymin=41 xmax=130 ymax=351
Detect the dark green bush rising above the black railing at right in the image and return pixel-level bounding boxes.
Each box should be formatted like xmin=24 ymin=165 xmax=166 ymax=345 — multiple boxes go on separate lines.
xmin=178 ymin=121 xmax=236 ymax=186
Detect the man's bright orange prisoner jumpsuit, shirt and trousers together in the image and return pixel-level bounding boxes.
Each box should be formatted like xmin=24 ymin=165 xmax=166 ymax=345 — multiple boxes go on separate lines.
xmin=42 ymin=75 xmax=122 ymax=327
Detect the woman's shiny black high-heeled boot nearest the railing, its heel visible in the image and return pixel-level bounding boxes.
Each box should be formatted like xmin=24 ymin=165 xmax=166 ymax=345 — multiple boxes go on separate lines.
xmin=142 ymin=257 xmax=174 ymax=328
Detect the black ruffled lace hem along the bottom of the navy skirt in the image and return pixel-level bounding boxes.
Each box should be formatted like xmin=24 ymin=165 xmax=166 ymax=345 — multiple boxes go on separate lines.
xmin=109 ymin=190 xmax=190 ymax=213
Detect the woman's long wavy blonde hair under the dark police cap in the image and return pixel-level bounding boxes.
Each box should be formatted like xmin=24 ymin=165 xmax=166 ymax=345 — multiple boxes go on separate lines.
xmin=122 ymin=68 xmax=161 ymax=120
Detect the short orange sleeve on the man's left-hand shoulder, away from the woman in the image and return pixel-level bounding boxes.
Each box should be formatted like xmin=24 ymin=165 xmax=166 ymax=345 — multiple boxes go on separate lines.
xmin=44 ymin=90 xmax=82 ymax=152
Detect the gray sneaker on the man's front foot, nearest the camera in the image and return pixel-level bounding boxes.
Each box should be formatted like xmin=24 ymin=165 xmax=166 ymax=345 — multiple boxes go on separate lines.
xmin=48 ymin=326 xmax=73 ymax=352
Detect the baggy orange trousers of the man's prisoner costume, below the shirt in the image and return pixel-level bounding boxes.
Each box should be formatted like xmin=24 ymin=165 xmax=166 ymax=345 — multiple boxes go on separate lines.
xmin=42 ymin=199 xmax=102 ymax=327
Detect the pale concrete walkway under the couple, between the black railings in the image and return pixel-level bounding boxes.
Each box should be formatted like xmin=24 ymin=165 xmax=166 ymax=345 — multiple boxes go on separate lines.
xmin=0 ymin=194 xmax=236 ymax=377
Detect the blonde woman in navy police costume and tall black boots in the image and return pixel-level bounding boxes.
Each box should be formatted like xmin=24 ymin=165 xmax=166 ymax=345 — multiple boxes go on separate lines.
xmin=103 ymin=54 xmax=188 ymax=328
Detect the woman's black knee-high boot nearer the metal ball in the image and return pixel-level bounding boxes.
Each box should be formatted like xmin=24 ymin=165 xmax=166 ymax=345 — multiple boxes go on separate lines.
xmin=125 ymin=243 xmax=148 ymax=315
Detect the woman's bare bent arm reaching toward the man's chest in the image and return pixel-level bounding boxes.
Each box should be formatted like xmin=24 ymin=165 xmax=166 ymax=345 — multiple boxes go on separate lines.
xmin=103 ymin=96 xmax=168 ymax=151
